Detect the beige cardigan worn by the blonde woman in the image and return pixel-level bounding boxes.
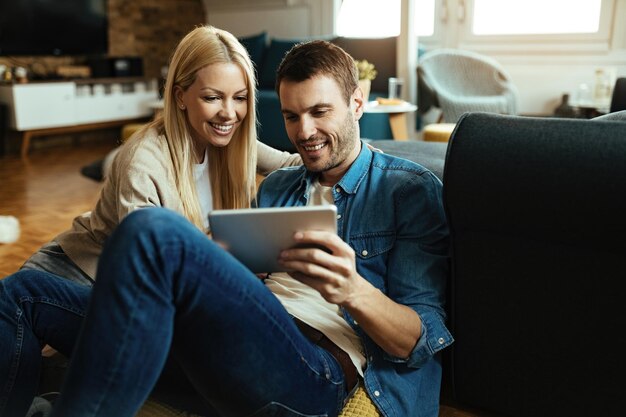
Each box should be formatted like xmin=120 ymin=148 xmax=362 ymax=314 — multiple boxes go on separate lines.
xmin=54 ymin=131 xmax=302 ymax=279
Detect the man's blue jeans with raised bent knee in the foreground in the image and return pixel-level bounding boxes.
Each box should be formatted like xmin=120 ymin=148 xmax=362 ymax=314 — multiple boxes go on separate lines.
xmin=48 ymin=208 xmax=346 ymax=417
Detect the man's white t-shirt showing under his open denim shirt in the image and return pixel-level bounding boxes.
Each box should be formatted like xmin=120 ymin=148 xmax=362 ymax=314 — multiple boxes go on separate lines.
xmin=265 ymin=181 xmax=366 ymax=376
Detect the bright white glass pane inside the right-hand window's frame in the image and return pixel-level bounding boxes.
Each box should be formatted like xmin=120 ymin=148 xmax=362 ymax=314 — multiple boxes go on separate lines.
xmin=472 ymin=0 xmax=602 ymax=35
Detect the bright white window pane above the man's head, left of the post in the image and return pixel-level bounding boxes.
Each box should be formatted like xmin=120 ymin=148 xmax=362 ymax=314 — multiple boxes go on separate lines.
xmin=337 ymin=0 xmax=401 ymax=38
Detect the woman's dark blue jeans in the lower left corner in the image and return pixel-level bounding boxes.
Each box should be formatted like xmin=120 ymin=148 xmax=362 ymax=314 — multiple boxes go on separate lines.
xmin=0 ymin=270 xmax=91 ymax=417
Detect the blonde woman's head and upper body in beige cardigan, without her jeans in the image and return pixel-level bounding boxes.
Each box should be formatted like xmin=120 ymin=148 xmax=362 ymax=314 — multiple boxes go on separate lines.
xmin=17 ymin=26 xmax=301 ymax=285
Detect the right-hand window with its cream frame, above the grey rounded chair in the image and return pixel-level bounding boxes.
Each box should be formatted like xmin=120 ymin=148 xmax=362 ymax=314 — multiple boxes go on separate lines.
xmin=410 ymin=0 xmax=615 ymax=53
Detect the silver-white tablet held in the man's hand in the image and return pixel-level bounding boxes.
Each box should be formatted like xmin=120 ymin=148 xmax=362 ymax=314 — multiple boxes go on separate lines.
xmin=209 ymin=205 xmax=337 ymax=273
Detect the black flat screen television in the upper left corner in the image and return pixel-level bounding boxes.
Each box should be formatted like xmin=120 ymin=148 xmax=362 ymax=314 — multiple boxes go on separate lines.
xmin=0 ymin=0 xmax=108 ymax=56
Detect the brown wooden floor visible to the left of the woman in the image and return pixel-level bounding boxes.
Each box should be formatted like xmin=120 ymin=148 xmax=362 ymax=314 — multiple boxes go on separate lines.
xmin=0 ymin=141 xmax=115 ymax=278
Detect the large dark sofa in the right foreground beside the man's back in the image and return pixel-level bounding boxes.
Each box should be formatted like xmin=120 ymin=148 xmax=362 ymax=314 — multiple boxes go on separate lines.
xmin=442 ymin=112 xmax=626 ymax=417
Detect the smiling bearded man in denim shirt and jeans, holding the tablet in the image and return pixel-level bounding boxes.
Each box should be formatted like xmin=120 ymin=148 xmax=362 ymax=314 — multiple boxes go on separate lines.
xmin=46 ymin=41 xmax=453 ymax=417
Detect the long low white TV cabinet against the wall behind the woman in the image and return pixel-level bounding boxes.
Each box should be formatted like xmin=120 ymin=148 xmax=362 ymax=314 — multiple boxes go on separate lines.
xmin=0 ymin=80 xmax=159 ymax=131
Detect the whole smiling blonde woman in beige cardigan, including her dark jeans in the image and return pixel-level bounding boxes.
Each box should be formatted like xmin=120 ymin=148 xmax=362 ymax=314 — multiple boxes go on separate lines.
xmin=0 ymin=26 xmax=301 ymax=416
